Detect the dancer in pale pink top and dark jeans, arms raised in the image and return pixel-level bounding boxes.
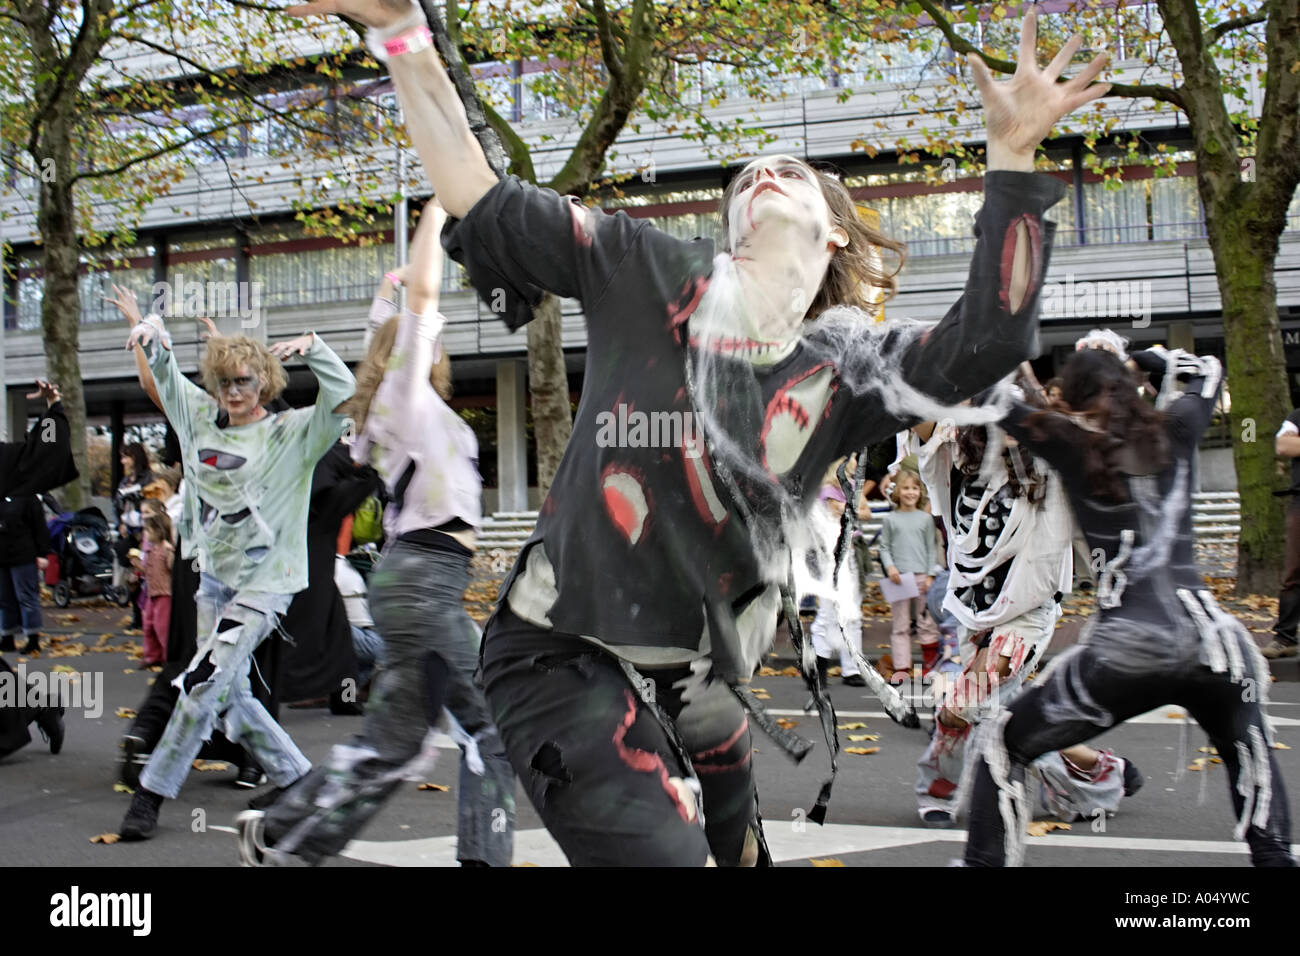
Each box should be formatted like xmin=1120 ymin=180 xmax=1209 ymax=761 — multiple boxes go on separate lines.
xmin=238 ymin=203 xmax=515 ymax=866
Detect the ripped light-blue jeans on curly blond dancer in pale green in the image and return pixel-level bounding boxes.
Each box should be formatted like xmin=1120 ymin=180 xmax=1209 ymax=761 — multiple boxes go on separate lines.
xmin=140 ymin=575 xmax=312 ymax=799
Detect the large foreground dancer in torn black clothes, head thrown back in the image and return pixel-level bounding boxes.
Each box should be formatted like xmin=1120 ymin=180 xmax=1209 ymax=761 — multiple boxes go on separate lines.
xmin=290 ymin=0 xmax=1108 ymax=865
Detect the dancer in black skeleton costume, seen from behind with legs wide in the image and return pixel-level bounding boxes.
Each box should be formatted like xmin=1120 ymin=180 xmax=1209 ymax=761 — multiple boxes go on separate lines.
xmin=966 ymin=349 xmax=1294 ymax=866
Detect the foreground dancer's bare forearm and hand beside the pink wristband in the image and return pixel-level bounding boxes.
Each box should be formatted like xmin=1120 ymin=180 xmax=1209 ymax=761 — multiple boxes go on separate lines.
xmin=285 ymin=0 xmax=497 ymax=219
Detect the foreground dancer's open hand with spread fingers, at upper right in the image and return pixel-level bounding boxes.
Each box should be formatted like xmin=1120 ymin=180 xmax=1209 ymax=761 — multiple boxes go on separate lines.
xmin=966 ymin=10 xmax=1110 ymax=168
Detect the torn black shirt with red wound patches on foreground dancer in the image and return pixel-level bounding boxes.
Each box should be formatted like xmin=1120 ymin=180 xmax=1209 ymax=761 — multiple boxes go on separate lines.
xmin=443 ymin=172 xmax=1065 ymax=680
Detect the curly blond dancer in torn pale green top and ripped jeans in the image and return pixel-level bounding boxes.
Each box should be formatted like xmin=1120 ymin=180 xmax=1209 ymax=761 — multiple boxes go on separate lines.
xmin=112 ymin=308 xmax=355 ymax=840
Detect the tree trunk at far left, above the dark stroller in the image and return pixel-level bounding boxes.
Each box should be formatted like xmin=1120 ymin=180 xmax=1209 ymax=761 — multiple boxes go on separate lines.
xmin=36 ymin=149 xmax=90 ymax=509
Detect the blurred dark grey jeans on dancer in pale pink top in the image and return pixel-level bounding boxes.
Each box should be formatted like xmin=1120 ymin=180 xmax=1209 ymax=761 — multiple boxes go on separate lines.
xmin=267 ymin=541 xmax=515 ymax=866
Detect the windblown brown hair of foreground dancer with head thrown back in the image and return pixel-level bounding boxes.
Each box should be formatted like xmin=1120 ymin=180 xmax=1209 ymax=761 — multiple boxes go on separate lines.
xmin=722 ymin=164 xmax=907 ymax=319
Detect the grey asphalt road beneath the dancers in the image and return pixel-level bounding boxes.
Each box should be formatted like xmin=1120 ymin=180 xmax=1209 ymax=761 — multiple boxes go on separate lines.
xmin=0 ymin=639 xmax=1300 ymax=868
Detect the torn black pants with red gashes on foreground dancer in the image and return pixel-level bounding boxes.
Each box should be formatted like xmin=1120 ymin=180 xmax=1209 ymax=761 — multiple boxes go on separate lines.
xmin=484 ymin=606 xmax=757 ymax=866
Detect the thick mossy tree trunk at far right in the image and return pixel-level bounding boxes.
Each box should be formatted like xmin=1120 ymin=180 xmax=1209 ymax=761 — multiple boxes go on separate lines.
xmin=1205 ymin=191 xmax=1291 ymax=594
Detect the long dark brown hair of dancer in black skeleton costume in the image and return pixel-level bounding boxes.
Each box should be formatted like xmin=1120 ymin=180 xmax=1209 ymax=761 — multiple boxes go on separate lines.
xmin=1024 ymin=349 xmax=1169 ymax=501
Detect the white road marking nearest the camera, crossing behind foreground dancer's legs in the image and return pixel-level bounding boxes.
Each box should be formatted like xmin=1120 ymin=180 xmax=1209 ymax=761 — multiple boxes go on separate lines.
xmin=343 ymin=821 xmax=1300 ymax=866
